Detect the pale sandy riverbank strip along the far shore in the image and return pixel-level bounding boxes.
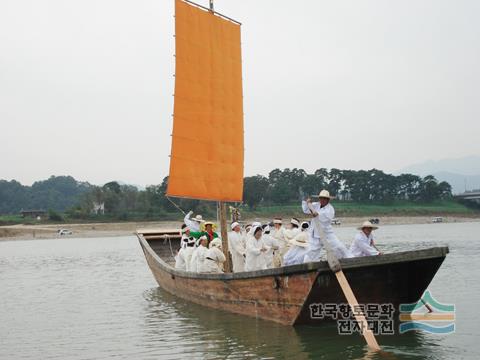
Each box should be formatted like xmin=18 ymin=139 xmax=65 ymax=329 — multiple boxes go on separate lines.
xmin=0 ymin=216 xmax=480 ymax=241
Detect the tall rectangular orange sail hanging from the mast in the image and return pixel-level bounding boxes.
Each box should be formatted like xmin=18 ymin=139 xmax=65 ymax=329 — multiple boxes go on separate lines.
xmin=167 ymin=0 xmax=244 ymax=202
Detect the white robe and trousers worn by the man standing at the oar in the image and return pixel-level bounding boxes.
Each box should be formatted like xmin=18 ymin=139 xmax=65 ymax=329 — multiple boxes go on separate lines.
xmin=302 ymin=201 xmax=352 ymax=261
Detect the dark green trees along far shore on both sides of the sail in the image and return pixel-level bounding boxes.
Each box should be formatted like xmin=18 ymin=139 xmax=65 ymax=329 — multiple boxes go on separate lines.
xmin=0 ymin=168 xmax=452 ymax=220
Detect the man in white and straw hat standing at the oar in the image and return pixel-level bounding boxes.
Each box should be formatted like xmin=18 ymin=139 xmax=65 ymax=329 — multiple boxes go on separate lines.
xmin=302 ymin=190 xmax=352 ymax=262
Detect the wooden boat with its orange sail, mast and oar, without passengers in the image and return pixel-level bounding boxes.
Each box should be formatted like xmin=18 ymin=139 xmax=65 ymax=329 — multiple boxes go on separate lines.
xmin=137 ymin=0 xmax=448 ymax=332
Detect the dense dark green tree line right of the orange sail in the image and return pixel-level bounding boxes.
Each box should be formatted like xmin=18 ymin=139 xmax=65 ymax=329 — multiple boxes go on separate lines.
xmin=244 ymin=168 xmax=452 ymax=209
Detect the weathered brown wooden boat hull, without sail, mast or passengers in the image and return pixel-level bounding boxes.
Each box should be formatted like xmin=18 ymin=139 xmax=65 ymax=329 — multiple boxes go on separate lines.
xmin=137 ymin=230 xmax=448 ymax=325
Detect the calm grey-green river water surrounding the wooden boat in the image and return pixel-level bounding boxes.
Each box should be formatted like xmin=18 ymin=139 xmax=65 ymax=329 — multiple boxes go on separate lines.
xmin=0 ymin=222 xmax=480 ymax=360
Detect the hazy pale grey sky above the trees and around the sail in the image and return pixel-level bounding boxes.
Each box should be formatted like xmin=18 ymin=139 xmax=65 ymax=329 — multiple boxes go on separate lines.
xmin=0 ymin=0 xmax=480 ymax=185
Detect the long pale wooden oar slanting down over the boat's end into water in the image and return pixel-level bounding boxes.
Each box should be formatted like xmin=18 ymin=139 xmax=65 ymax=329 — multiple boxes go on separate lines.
xmin=307 ymin=202 xmax=381 ymax=351
